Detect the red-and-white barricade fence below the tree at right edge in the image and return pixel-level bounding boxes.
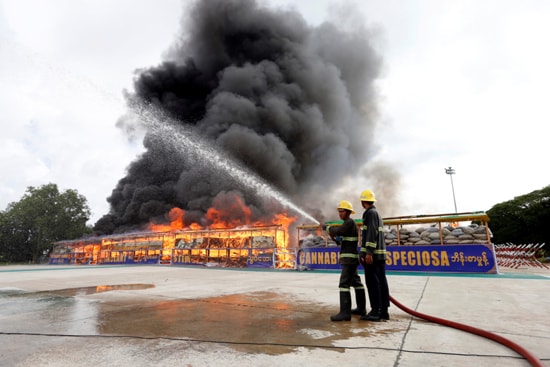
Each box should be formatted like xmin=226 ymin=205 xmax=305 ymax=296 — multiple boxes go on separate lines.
xmin=494 ymin=243 xmax=550 ymax=269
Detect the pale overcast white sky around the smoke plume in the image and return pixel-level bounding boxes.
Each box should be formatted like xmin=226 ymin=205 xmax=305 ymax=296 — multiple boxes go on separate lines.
xmin=0 ymin=0 xmax=550 ymax=224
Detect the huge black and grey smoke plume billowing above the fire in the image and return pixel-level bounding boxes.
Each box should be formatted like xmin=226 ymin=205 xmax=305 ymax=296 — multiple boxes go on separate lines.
xmin=95 ymin=0 xmax=381 ymax=233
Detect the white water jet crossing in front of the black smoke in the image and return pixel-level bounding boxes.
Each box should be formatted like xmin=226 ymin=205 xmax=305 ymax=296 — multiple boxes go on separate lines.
xmin=131 ymin=103 xmax=319 ymax=223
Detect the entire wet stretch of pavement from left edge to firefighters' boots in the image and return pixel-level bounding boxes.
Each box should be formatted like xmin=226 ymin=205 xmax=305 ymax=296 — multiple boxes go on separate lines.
xmin=0 ymin=284 xmax=405 ymax=354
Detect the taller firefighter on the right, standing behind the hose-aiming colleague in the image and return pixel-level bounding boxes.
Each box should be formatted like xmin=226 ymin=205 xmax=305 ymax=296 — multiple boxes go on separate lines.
xmin=359 ymin=190 xmax=390 ymax=321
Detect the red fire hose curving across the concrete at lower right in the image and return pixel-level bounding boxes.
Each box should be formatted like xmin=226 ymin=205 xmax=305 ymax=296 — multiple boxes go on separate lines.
xmin=390 ymin=296 xmax=545 ymax=367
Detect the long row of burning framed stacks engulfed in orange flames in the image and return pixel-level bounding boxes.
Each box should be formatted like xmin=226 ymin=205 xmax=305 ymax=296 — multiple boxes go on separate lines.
xmin=50 ymin=226 xmax=295 ymax=268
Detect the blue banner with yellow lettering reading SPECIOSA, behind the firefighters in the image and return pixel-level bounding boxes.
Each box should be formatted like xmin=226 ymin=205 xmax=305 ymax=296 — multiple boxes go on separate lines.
xmin=297 ymin=244 xmax=497 ymax=273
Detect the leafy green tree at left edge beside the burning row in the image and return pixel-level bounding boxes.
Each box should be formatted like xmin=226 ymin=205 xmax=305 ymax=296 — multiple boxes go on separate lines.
xmin=0 ymin=183 xmax=91 ymax=263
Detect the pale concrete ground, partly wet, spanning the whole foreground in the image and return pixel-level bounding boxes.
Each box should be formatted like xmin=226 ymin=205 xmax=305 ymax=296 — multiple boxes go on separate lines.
xmin=0 ymin=265 xmax=550 ymax=367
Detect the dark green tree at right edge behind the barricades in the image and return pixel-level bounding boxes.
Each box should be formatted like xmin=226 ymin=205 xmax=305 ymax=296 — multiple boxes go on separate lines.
xmin=487 ymin=186 xmax=550 ymax=253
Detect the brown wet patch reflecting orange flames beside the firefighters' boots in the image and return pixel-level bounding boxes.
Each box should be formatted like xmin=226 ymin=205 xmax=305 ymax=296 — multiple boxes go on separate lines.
xmin=98 ymin=292 xmax=406 ymax=354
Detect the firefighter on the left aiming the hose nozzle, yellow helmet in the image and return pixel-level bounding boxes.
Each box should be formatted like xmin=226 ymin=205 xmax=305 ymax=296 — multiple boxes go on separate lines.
xmin=323 ymin=200 xmax=367 ymax=321
